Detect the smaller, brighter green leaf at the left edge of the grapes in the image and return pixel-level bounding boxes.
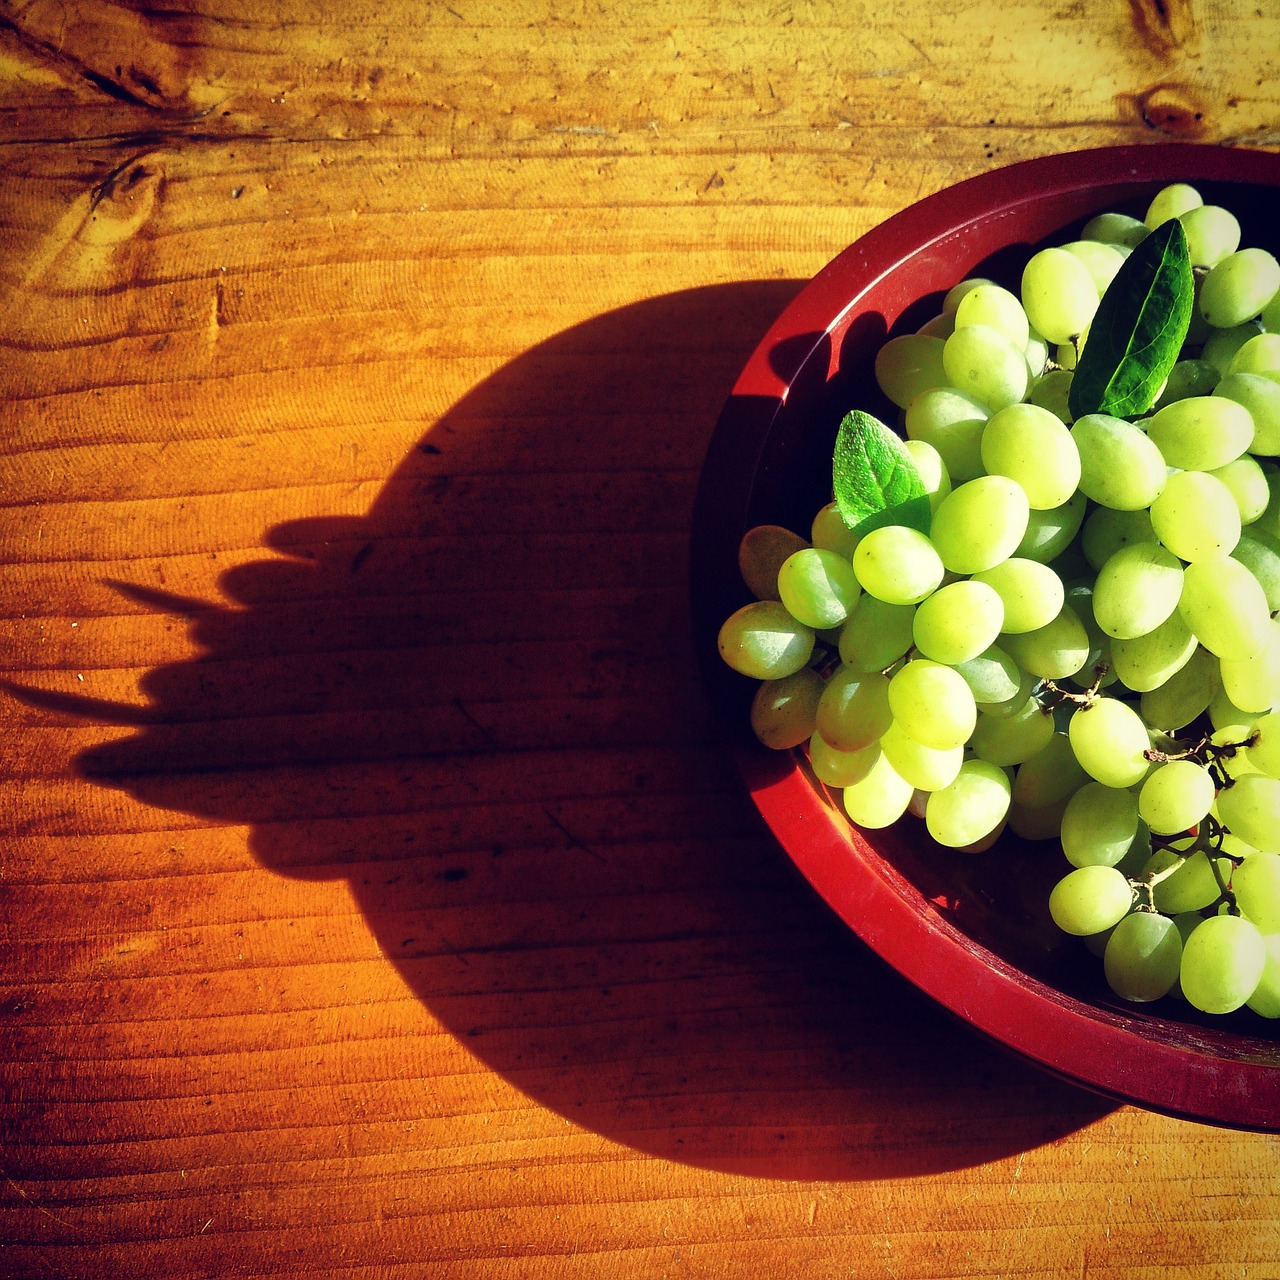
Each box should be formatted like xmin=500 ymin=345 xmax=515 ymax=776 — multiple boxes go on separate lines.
xmin=831 ymin=410 xmax=932 ymax=535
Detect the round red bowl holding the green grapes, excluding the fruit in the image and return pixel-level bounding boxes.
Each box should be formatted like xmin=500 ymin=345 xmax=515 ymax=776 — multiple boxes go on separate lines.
xmin=691 ymin=145 xmax=1280 ymax=1132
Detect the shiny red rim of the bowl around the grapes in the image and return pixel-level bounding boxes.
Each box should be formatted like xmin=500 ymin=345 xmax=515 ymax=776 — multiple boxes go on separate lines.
xmin=690 ymin=143 xmax=1280 ymax=1132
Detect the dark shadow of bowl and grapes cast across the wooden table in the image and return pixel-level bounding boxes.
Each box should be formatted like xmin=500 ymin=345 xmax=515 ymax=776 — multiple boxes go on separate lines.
xmin=45 ymin=282 xmax=1114 ymax=1179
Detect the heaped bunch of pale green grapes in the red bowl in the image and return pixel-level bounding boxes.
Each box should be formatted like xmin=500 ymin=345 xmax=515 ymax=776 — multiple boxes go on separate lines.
xmin=719 ymin=184 xmax=1280 ymax=1018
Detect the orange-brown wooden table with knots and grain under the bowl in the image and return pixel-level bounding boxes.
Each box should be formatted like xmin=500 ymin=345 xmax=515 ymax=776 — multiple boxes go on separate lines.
xmin=0 ymin=0 xmax=1280 ymax=1280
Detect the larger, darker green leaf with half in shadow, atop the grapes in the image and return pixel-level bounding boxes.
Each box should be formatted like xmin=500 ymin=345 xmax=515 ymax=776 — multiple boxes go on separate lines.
xmin=1068 ymin=218 xmax=1196 ymax=417
